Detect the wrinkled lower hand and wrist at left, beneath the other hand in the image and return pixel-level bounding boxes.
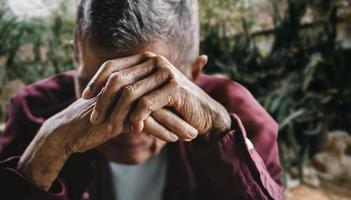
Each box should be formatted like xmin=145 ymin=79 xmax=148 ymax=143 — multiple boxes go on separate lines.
xmin=17 ymin=94 xmax=190 ymax=190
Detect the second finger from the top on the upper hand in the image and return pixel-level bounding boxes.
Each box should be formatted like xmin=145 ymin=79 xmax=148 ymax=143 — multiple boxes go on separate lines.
xmin=90 ymin=60 xmax=158 ymax=123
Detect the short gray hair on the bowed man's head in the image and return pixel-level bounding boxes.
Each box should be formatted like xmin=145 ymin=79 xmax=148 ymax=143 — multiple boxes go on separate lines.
xmin=77 ymin=0 xmax=199 ymax=62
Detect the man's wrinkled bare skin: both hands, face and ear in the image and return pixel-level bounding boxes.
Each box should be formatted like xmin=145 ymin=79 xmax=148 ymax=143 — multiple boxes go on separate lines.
xmin=18 ymin=41 xmax=230 ymax=190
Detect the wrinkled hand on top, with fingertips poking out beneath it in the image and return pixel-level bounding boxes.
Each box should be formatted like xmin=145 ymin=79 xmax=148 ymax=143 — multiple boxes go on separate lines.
xmin=83 ymin=52 xmax=230 ymax=142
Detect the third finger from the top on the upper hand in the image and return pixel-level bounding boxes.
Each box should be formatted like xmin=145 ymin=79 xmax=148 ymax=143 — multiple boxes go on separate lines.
xmin=110 ymin=70 xmax=172 ymax=133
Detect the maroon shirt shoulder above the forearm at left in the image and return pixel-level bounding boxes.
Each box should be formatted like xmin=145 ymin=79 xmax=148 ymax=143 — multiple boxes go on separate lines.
xmin=5 ymin=71 xmax=75 ymax=133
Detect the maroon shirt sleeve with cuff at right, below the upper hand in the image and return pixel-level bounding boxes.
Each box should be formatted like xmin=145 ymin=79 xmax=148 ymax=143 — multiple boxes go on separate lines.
xmin=190 ymin=114 xmax=284 ymax=200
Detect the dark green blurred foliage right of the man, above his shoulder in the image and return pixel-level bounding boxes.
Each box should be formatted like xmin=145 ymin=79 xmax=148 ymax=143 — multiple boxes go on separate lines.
xmin=201 ymin=0 xmax=351 ymax=183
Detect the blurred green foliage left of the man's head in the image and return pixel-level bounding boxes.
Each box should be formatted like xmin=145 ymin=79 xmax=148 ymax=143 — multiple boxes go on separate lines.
xmin=0 ymin=3 xmax=74 ymax=85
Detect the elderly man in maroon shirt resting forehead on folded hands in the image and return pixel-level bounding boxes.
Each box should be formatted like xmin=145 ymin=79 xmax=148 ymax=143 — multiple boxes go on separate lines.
xmin=0 ymin=0 xmax=283 ymax=200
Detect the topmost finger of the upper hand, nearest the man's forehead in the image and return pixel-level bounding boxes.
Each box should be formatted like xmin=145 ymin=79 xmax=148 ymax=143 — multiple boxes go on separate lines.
xmin=82 ymin=52 xmax=155 ymax=99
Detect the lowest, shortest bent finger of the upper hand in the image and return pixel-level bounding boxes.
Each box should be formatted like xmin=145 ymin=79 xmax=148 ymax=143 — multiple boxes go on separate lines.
xmin=130 ymin=84 xmax=178 ymax=131
